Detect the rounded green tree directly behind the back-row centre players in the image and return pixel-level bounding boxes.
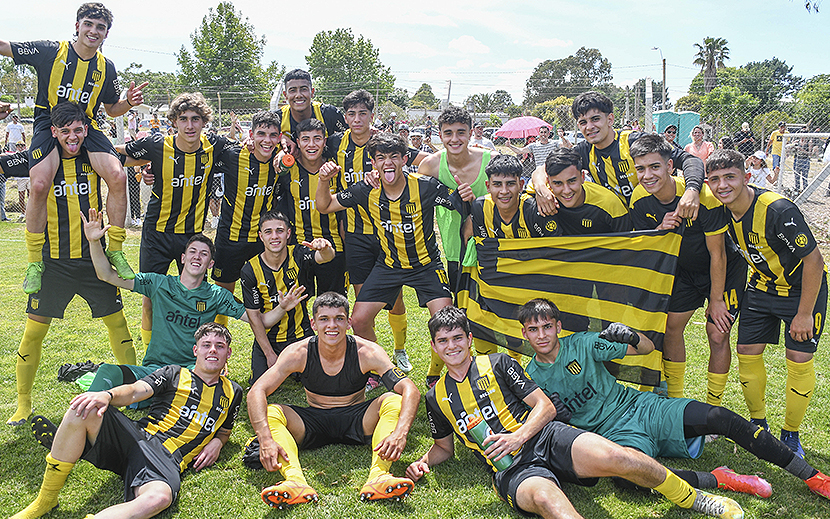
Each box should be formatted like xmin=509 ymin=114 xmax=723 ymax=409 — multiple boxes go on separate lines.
xmin=305 ymin=29 xmax=395 ymax=105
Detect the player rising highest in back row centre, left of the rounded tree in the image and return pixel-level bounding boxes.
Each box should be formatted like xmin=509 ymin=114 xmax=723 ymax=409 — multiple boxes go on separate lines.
xmin=276 ymin=69 xmax=347 ymax=156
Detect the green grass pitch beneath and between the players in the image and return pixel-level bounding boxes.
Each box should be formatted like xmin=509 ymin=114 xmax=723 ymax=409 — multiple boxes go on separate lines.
xmin=0 ymin=223 xmax=830 ymax=519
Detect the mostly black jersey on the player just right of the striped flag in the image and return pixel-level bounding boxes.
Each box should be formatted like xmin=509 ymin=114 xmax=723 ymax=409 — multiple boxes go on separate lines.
xmin=631 ymin=177 xmax=736 ymax=274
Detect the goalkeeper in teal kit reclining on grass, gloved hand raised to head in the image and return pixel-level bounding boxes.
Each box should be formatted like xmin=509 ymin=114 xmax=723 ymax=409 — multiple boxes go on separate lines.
xmin=518 ymin=299 xmax=830 ymax=506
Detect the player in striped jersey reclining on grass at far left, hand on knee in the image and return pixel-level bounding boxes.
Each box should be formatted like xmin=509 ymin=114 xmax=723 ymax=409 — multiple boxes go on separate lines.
xmin=12 ymin=322 xmax=242 ymax=519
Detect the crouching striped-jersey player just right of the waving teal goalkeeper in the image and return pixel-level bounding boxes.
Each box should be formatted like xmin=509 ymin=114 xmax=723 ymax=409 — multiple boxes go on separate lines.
xmin=240 ymin=211 xmax=334 ymax=384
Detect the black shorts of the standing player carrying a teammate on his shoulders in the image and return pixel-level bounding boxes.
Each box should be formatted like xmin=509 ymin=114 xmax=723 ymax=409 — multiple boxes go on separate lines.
xmin=26 ymin=258 xmax=124 ymax=319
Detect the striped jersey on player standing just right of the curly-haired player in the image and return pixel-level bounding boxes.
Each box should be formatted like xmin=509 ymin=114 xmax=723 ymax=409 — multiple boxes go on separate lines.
xmin=215 ymin=145 xmax=278 ymax=243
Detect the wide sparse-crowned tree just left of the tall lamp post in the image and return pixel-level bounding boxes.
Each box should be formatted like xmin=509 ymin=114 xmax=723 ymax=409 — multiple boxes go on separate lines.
xmin=524 ymin=47 xmax=613 ymax=107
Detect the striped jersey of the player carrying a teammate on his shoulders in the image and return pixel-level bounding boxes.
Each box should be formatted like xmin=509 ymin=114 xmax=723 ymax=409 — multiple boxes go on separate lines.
xmin=43 ymin=148 xmax=104 ymax=259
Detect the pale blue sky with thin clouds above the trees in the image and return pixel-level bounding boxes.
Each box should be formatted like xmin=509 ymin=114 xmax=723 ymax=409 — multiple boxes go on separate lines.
xmin=0 ymin=0 xmax=830 ymax=103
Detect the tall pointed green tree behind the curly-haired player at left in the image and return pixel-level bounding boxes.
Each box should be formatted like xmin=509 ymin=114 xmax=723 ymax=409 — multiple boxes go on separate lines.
xmin=177 ymin=2 xmax=284 ymax=108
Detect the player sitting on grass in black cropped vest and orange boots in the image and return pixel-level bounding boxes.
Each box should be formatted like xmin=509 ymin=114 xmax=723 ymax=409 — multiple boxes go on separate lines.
xmin=248 ymin=292 xmax=421 ymax=508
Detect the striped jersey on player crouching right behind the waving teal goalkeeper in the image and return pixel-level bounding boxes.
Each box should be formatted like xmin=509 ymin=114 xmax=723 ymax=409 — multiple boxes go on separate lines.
xmin=244 ymin=245 xmax=315 ymax=345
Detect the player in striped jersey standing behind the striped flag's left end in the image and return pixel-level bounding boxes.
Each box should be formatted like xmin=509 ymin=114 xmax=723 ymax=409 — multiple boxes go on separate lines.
xmin=472 ymin=155 xmax=562 ymax=239
